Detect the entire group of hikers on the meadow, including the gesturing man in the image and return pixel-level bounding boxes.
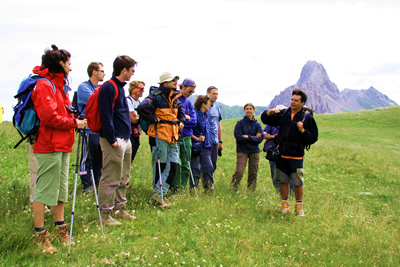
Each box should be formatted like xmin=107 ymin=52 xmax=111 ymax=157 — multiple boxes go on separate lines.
xmin=27 ymin=45 xmax=318 ymax=253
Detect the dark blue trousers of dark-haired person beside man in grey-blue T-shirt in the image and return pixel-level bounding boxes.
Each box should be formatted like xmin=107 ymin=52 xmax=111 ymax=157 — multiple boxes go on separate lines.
xmin=190 ymin=148 xmax=214 ymax=189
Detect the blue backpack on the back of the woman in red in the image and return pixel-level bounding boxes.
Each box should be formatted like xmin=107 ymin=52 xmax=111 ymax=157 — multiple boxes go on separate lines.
xmin=13 ymin=74 xmax=56 ymax=148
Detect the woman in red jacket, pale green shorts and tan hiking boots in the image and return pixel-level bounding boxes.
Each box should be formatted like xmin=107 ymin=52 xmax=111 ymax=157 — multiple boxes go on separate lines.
xmin=32 ymin=45 xmax=87 ymax=253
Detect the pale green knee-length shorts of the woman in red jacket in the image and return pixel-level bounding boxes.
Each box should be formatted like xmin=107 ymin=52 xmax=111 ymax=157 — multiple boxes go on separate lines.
xmin=33 ymin=152 xmax=70 ymax=206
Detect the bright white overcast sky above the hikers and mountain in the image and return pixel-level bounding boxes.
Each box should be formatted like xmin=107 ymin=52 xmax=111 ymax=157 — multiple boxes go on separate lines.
xmin=0 ymin=0 xmax=400 ymax=120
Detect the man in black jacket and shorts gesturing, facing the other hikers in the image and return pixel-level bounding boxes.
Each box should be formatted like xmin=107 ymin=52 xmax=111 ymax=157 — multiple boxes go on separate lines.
xmin=261 ymin=89 xmax=318 ymax=217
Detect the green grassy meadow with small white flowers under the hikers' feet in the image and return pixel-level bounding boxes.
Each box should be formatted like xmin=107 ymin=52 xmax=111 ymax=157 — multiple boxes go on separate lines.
xmin=0 ymin=106 xmax=400 ymax=266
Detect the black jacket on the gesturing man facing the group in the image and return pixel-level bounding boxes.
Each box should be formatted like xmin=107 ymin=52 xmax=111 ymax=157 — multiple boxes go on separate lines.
xmin=261 ymin=108 xmax=318 ymax=157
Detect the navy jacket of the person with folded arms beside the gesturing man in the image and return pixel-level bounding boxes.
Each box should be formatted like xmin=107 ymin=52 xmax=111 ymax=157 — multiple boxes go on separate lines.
xmin=234 ymin=116 xmax=264 ymax=153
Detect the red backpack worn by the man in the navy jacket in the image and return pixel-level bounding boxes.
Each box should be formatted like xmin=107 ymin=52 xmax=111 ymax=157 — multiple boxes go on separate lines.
xmin=85 ymin=79 xmax=119 ymax=133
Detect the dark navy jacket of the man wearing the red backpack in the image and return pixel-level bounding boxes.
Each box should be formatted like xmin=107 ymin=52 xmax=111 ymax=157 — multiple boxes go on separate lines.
xmin=99 ymin=75 xmax=131 ymax=144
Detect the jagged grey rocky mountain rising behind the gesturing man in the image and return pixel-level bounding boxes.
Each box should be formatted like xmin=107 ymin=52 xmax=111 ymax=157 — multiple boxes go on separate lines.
xmin=268 ymin=60 xmax=397 ymax=113
